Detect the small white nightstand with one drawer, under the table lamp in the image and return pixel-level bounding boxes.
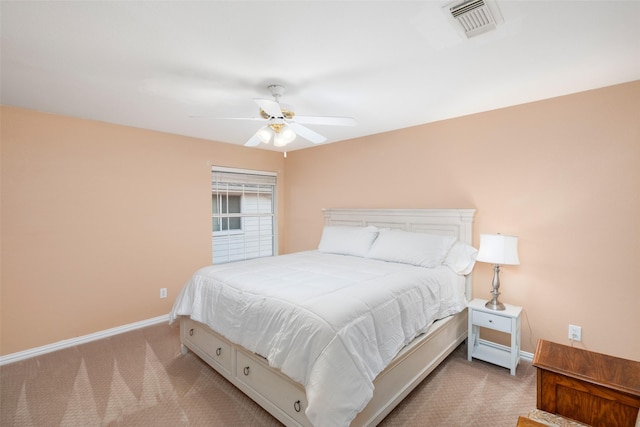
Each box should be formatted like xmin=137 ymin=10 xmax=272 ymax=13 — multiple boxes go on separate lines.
xmin=467 ymin=299 xmax=522 ymax=375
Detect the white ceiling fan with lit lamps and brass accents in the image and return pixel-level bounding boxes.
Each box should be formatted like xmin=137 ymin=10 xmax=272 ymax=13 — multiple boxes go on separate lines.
xmin=229 ymin=85 xmax=356 ymax=147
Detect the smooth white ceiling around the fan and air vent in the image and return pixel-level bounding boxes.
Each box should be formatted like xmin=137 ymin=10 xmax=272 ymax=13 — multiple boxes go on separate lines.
xmin=0 ymin=0 xmax=640 ymax=151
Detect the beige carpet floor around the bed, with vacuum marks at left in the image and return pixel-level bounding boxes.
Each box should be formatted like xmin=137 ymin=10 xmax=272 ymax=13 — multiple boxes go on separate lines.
xmin=0 ymin=324 xmax=535 ymax=427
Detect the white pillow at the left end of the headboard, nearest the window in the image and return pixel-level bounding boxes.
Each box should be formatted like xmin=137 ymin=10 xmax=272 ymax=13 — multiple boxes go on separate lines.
xmin=318 ymin=226 xmax=378 ymax=257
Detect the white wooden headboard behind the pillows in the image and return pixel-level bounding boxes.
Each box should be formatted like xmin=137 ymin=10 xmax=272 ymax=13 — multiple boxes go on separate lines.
xmin=322 ymin=208 xmax=476 ymax=301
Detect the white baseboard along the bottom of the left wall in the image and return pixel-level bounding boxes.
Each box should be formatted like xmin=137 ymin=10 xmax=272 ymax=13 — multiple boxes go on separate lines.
xmin=0 ymin=314 xmax=169 ymax=366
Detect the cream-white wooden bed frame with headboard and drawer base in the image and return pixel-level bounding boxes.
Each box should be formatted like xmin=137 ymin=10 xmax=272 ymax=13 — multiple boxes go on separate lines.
xmin=180 ymin=209 xmax=475 ymax=426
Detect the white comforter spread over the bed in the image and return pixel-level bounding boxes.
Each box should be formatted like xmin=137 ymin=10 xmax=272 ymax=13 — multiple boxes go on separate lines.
xmin=170 ymin=251 xmax=465 ymax=426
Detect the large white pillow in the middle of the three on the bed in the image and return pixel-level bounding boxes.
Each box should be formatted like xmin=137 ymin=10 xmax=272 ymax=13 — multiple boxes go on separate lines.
xmin=367 ymin=230 xmax=456 ymax=268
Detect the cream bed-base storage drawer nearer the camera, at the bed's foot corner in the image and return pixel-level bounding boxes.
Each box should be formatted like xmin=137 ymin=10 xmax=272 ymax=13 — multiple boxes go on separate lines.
xmin=235 ymin=351 xmax=309 ymax=425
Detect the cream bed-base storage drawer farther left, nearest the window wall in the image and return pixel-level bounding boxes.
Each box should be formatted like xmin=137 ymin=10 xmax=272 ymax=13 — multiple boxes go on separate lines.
xmin=181 ymin=318 xmax=233 ymax=373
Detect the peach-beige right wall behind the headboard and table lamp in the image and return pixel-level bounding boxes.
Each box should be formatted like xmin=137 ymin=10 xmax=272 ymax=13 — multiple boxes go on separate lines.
xmin=286 ymin=82 xmax=640 ymax=360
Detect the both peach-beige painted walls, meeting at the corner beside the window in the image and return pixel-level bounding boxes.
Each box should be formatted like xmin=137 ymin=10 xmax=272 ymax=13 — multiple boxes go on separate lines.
xmin=0 ymin=82 xmax=640 ymax=360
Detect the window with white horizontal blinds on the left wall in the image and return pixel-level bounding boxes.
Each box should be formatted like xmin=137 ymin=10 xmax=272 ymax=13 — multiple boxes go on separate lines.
xmin=211 ymin=166 xmax=277 ymax=264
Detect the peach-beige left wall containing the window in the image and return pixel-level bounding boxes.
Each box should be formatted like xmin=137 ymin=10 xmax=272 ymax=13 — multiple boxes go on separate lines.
xmin=0 ymin=107 xmax=285 ymax=355
